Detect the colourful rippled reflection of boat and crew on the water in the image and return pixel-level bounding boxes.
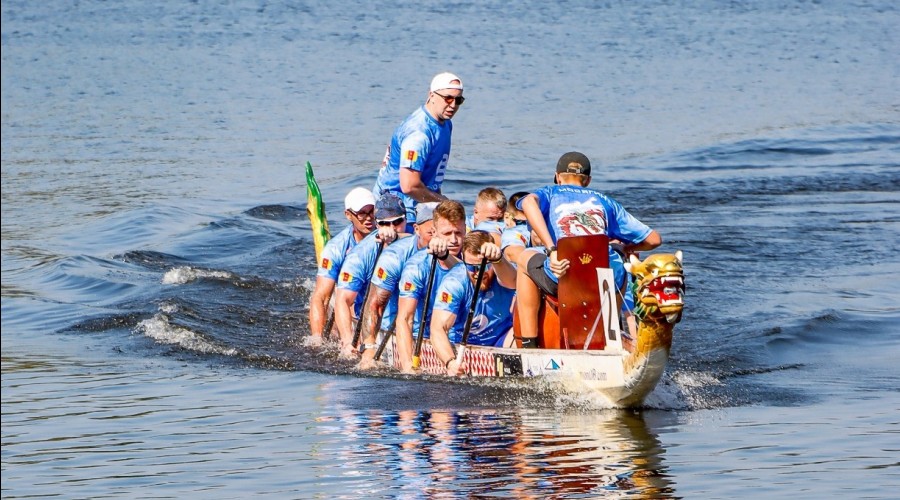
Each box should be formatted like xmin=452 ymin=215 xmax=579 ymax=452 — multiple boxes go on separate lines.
xmin=321 ymin=409 xmax=674 ymax=498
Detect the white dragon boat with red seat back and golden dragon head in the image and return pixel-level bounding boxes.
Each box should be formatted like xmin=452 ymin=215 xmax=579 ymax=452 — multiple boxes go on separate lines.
xmin=382 ymin=235 xmax=685 ymax=407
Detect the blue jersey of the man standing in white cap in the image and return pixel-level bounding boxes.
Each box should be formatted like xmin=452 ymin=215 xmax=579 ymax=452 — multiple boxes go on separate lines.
xmin=372 ymin=105 xmax=453 ymax=221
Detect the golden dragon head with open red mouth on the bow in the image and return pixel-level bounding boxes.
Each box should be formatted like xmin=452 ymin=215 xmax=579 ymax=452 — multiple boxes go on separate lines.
xmin=625 ymin=250 xmax=684 ymax=324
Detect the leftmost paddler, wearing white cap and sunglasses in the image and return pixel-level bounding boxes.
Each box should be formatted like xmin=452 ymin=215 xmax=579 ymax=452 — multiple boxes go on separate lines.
xmin=308 ymin=187 xmax=375 ymax=345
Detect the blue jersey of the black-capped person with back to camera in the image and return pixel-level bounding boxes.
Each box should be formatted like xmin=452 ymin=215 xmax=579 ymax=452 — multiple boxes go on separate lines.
xmin=516 ymin=185 xmax=651 ymax=287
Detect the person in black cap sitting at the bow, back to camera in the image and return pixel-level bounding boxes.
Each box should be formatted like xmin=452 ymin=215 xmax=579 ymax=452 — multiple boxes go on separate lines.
xmin=516 ymin=152 xmax=662 ymax=348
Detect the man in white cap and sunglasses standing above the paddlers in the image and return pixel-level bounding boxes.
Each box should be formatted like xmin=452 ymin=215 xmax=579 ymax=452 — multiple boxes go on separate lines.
xmin=372 ymin=73 xmax=465 ymax=231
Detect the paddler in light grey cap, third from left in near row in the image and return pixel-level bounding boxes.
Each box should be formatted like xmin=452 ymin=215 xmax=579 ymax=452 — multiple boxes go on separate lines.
xmin=359 ymin=202 xmax=438 ymax=370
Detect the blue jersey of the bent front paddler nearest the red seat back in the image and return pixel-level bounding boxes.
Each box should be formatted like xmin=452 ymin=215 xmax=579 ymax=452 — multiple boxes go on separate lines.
xmin=434 ymin=264 xmax=516 ymax=346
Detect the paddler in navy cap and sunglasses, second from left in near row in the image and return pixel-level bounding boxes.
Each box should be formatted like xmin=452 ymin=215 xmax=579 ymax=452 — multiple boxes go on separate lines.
xmin=334 ymin=189 xmax=409 ymax=358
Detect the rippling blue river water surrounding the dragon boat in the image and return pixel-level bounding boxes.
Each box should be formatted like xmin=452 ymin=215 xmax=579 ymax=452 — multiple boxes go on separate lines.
xmin=2 ymin=0 xmax=900 ymax=499
